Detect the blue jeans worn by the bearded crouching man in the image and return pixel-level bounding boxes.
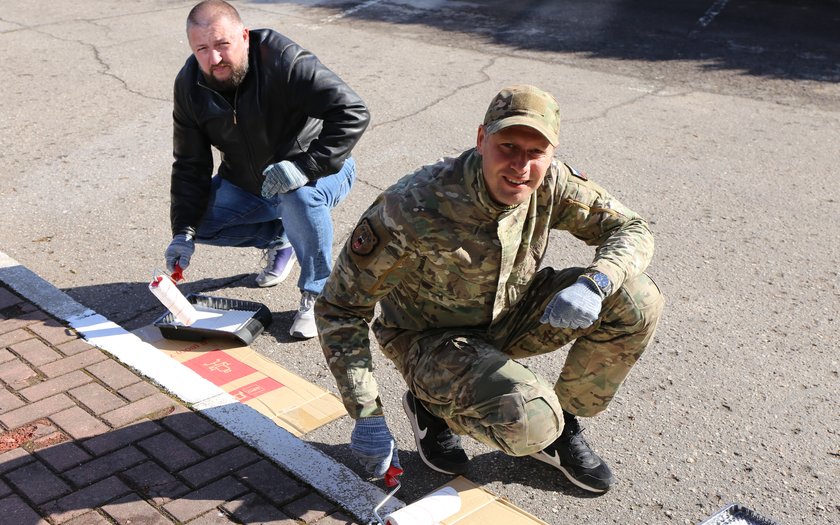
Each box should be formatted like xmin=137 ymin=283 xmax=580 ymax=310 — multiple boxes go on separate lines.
xmin=195 ymin=157 xmax=356 ymax=294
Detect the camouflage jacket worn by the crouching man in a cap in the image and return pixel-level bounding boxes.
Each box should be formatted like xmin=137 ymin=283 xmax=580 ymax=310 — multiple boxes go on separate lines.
xmin=315 ymin=150 xmax=653 ymax=418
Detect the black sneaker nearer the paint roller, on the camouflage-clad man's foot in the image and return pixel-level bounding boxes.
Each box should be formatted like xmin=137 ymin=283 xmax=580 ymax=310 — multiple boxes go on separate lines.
xmin=403 ymin=392 xmax=470 ymax=476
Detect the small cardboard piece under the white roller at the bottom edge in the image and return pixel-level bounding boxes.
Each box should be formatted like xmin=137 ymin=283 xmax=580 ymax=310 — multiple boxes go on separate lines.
xmin=440 ymin=476 xmax=548 ymax=525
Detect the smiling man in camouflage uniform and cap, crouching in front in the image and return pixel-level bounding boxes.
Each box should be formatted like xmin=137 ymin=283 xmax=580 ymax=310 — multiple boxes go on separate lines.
xmin=315 ymin=86 xmax=663 ymax=492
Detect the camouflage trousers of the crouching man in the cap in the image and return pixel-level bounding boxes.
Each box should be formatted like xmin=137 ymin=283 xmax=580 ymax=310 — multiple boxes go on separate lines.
xmin=380 ymin=268 xmax=664 ymax=456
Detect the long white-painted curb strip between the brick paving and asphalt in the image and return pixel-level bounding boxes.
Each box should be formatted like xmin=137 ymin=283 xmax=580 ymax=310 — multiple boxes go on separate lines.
xmin=0 ymin=251 xmax=405 ymax=523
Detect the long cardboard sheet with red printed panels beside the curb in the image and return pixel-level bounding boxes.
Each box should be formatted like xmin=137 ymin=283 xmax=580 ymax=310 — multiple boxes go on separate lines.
xmin=134 ymin=326 xmax=346 ymax=437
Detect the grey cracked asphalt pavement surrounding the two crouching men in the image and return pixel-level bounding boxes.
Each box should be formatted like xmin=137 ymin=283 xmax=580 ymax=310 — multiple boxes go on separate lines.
xmin=0 ymin=0 xmax=840 ymax=524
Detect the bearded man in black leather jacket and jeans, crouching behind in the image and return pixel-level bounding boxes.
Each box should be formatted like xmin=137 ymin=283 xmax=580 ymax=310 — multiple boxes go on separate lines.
xmin=165 ymin=0 xmax=370 ymax=338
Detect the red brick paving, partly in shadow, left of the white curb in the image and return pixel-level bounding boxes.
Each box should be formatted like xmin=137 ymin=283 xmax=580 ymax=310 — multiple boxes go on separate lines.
xmin=0 ymin=283 xmax=357 ymax=525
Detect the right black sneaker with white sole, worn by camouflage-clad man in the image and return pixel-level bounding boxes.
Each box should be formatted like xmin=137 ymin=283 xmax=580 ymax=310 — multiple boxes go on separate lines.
xmin=531 ymin=418 xmax=615 ymax=493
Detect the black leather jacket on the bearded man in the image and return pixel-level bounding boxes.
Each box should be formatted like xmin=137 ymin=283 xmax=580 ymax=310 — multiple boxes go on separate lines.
xmin=170 ymin=29 xmax=370 ymax=235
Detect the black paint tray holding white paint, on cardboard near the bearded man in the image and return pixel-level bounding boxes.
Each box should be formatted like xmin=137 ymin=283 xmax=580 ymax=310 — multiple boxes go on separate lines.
xmin=154 ymin=294 xmax=271 ymax=345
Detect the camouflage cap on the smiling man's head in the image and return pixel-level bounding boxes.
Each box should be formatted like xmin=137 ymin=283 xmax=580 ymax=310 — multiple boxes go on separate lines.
xmin=484 ymin=85 xmax=560 ymax=146
